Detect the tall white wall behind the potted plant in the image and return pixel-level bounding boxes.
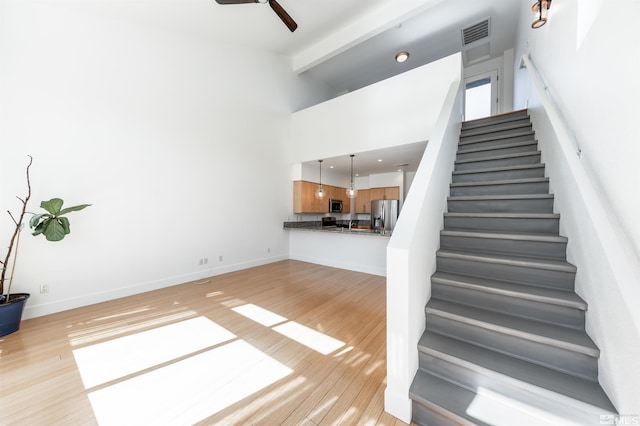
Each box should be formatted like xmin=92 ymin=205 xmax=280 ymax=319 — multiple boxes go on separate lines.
xmin=0 ymin=0 xmax=326 ymax=317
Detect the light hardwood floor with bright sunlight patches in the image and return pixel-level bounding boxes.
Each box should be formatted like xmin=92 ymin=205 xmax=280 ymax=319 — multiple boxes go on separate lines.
xmin=0 ymin=260 xmax=405 ymax=426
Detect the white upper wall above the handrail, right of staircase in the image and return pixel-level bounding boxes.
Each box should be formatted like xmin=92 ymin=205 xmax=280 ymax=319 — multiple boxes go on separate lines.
xmin=515 ymin=0 xmax=640 ymax=259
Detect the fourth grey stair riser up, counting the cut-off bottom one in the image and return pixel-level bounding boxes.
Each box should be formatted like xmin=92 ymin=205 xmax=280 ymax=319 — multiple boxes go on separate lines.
xmin=431 ymin=281 xmax=584 ymax=329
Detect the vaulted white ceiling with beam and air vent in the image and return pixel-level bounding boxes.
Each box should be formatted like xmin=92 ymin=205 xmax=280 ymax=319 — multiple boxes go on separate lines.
xmin=56 ymin=0 xmax=526 ymax=175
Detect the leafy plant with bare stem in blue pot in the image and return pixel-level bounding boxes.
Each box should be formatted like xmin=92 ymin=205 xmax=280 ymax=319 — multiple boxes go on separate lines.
xmin=0 ymin=156 xmax=90 ymax=336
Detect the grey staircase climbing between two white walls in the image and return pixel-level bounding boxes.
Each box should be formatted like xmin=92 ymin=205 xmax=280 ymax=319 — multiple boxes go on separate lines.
xmin=410 ymin=110 xmax=615 ymax=426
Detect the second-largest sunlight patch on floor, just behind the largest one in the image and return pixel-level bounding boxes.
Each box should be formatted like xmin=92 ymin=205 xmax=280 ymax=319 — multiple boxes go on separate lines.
xmin=73 ymin=317 xmax=236 ymax=389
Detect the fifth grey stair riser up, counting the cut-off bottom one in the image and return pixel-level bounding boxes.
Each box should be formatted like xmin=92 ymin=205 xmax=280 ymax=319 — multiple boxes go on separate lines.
xmin=436 ymin=256 xmax=575 ymax=291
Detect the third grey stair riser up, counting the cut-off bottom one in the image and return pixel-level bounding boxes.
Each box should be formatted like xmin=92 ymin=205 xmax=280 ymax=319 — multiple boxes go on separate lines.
xmin=427 ymin=312 xmax=598 ymax=380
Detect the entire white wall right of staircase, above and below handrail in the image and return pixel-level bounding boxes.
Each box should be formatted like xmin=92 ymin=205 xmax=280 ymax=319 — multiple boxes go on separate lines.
xmin=515 ymin=0 xmax=640 ymax=414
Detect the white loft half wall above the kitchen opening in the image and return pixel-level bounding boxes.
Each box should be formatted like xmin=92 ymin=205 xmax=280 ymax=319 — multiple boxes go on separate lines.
xmin=291 ymin=55 xmax=459 ymax=162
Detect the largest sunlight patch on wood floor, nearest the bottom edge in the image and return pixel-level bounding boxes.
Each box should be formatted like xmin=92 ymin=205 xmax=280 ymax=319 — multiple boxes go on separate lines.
xmin=89 ymin=340 xmax=293 ymax=426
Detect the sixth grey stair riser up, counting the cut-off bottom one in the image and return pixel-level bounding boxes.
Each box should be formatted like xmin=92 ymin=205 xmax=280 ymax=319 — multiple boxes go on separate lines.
xmin=440 ymin=235 xmax=567 ymax=260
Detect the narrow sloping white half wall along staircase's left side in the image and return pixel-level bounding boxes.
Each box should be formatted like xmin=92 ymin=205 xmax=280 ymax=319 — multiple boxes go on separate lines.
xmin=384 ymin=71 xmax=462 ymax=423
